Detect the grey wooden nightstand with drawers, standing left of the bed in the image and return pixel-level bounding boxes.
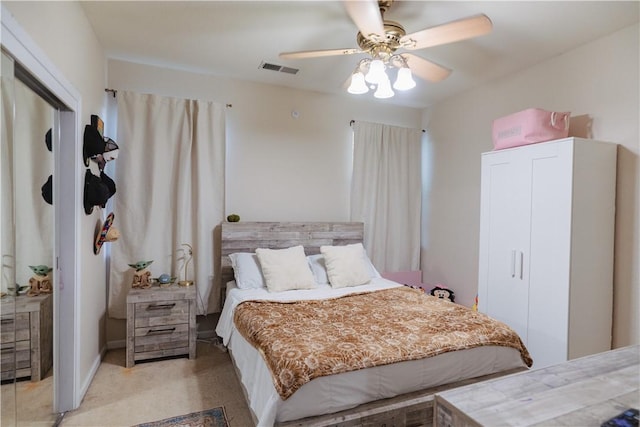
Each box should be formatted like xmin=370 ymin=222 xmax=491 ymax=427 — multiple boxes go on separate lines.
xmin=127 ymin=285 xmax=196 ymax=368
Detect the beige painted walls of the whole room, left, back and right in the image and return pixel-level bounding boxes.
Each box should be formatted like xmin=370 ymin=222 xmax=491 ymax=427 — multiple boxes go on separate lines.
xmin=3 ymin=1 xmax=640 ymax=384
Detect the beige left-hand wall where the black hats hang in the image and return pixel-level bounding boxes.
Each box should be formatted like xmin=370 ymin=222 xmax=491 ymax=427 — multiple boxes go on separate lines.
xmin=2 ymin=1 xmax=106 ymax=404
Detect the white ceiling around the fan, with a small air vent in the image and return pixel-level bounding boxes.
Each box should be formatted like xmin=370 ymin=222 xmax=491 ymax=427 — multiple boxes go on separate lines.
xmin=82 ymin=0 xmax=640 ymax=108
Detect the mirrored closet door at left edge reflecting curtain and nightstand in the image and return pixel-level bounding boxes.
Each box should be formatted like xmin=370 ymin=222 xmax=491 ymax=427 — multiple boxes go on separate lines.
xmin=0 ymin=48 xmax=57 ymax=425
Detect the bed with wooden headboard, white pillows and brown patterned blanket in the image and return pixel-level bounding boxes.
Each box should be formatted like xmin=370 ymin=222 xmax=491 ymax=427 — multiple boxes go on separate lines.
xmin=216 ymin=222 xmax=531 ymax=427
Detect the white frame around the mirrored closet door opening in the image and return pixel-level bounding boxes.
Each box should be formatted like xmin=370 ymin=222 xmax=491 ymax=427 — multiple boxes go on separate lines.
xmin=0 ymin=5 xmax=82 ymax=412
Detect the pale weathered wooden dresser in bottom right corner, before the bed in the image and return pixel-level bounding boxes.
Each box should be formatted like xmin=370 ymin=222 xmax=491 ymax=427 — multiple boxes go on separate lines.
xmin=434 ymin=345 xmax=640 ymax=427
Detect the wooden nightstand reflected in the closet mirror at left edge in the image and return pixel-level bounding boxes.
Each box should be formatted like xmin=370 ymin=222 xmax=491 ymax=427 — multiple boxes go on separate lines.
xmin=0 ymin=294 xmax=53 ymax=381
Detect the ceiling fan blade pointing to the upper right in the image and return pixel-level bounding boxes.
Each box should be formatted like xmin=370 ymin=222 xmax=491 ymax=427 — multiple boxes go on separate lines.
xmin=400 ymin=14 xmax=493 ymax=50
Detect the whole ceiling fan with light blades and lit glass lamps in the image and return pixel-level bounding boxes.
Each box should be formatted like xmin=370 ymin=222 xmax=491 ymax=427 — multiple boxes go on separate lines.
xmin=280 ymin=0 xmax=492 ymax=98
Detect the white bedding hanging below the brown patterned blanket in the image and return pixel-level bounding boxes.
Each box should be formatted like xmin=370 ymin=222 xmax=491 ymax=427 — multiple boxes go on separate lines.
xmin=228 ymin=326 xmax=526 ymax=427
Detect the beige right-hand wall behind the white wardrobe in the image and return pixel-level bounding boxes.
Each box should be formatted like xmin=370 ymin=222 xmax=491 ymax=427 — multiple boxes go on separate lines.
xmin=422 ymin=25 xmax=640 ymax=347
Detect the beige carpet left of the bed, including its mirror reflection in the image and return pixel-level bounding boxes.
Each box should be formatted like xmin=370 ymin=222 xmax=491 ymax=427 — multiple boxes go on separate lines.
xmin=3 ymin=341 xmax=253 ymax=427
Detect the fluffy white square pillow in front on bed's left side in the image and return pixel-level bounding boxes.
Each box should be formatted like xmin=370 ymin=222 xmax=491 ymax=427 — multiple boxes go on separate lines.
xmin=256 ymin=245 xmax=316 ymax=292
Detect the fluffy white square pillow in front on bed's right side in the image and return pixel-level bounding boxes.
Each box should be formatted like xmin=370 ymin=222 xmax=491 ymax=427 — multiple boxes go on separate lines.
xmin=320 ymin=243 xmax=373 ymax=288
